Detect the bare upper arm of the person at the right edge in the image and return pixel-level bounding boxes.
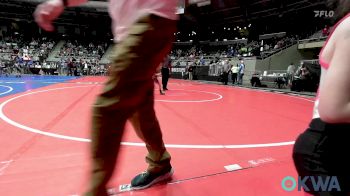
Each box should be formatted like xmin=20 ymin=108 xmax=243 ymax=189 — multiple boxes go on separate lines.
xmin=319 ymin=22 xmax=350 ymax=123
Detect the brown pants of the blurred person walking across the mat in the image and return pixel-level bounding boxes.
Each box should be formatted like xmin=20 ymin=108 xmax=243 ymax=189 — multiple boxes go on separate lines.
xmin=86 ymin=15 xmax=176 ymax=196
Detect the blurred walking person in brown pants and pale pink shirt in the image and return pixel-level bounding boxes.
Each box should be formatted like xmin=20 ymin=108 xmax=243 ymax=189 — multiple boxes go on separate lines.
xmin=34 ymin=0 xmax=178 ymax=196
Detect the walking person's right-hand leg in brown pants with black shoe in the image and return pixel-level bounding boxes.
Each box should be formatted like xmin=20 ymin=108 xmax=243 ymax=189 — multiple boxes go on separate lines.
xmin=130 ymin=91 xmax=173 ymax=189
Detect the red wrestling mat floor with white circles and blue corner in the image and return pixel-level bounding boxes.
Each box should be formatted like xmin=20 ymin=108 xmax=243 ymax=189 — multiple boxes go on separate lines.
xmin=0 ymin=76 xmax=313 ymax=196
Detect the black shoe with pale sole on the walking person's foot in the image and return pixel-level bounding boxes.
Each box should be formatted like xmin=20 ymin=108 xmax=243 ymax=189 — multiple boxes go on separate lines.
xmin=131 ymin=167 xmax=174 ymax=190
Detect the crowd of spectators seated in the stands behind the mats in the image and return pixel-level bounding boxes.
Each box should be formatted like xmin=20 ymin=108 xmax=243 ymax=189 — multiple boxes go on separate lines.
xmin=0 ymin=28 xmax=329 ymax=91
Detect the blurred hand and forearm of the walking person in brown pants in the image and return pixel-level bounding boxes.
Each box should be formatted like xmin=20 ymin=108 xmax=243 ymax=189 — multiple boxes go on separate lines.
xmin=34 ymin=0 xmax=88 ymax=31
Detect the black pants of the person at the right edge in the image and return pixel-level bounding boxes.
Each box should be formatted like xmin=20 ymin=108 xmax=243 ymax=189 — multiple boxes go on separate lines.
xmin=293 ymin=119 xmax=350 ymax=196
